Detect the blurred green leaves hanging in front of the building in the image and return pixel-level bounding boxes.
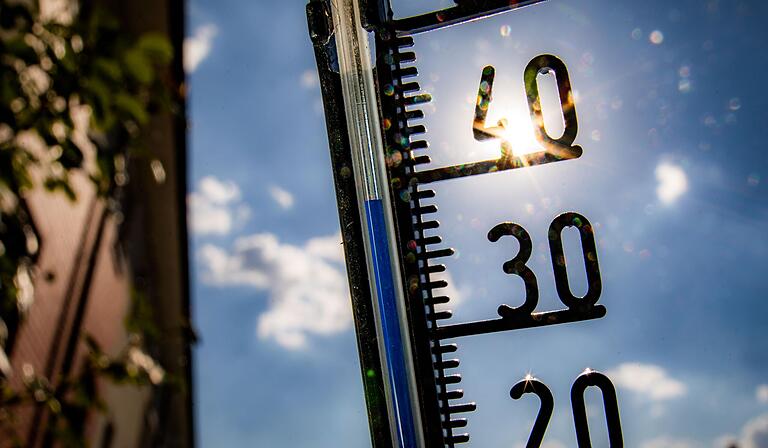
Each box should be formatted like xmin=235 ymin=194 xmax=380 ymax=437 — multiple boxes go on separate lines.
xmin=0 ymin=0 xmax=174 ymax=446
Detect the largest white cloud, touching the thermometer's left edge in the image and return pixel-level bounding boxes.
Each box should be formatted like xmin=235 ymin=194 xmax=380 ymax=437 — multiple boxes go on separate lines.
xmin=199 ymin=233 xmax=352 ymax=350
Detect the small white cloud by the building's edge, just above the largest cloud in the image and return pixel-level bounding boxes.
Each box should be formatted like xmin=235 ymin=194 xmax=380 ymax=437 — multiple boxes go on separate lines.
xmin=187 ymin=176 xmax=250 ymax=235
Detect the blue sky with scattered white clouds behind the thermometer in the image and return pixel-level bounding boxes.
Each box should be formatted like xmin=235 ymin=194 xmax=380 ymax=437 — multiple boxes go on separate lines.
xmin=185 ymin=0 xmax=768 ymax=448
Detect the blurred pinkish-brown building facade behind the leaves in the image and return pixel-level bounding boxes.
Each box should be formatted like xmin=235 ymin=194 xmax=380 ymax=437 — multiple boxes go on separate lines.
xmin=0 ymin=0 xmax=194 ymax=448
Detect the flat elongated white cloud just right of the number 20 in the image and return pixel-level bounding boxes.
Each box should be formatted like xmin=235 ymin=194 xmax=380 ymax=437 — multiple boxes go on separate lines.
xmin=606 ymin=362 xmax=688 ymax=401
